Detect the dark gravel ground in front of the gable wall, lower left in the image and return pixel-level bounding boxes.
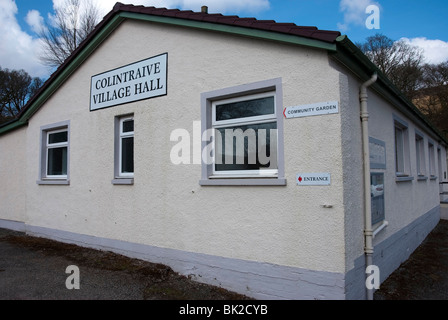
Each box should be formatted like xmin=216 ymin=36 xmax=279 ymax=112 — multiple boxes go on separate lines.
xmin=0 ymin=229 xmax=252 ymax=300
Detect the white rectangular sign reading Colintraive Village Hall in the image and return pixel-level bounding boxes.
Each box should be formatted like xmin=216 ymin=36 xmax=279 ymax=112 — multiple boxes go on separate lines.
xmin=90 ymin=53 xmax=168 ymax=111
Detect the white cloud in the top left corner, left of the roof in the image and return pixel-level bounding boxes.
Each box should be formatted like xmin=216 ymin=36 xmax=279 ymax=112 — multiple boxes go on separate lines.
xmin=0 ymin=0 xmax=48 ymax=77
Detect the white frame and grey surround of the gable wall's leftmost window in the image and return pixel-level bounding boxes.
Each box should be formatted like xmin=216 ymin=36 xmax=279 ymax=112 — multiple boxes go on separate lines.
xmin=36 ymin=120 xmax=70 ymax=185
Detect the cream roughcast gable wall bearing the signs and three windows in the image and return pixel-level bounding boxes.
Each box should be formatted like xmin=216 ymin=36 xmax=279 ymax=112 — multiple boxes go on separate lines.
xmin=21 ymin=21 xmax=346 ymax=272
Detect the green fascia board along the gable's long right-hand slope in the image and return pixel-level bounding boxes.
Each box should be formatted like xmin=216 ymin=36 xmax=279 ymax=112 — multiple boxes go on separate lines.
xmin=119 ymin=12 xmax=336 ymax=51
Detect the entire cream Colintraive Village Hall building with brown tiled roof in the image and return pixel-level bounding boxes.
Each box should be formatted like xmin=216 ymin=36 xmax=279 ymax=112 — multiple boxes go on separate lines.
xmin=0 ymin=3 xmax=447 ymax=299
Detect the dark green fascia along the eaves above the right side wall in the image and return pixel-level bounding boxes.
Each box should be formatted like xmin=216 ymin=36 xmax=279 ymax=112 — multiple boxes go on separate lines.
xmin=330 ymin=35 xmax=448 ymax=145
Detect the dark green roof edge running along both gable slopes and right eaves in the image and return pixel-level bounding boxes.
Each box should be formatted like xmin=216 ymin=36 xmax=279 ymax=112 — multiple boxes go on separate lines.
xmin=0 ymin=11 xmax=448 ymax=145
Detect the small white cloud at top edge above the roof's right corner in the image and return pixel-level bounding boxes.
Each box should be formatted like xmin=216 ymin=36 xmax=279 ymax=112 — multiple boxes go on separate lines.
xmin=337 ymin=0 xmax=380 ymax=32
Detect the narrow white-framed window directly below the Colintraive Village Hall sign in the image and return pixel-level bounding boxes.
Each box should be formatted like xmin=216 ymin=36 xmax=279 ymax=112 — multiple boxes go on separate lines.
xmin=112 ymin=115 xmax=134 ymax=184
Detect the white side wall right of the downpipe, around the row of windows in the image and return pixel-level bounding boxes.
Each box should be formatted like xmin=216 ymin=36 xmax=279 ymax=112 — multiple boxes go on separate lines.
xmin=369 ymin=90 xmax=444 ymax=242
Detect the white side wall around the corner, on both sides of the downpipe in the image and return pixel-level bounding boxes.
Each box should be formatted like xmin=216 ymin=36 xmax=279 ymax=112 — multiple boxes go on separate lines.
xmin=336 ymin=66 xmax=446 ymax=271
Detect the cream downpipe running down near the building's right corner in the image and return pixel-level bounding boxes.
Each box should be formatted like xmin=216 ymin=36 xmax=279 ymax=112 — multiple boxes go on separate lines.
xmin=359 ymin=73 xmax=377 ymax=300
